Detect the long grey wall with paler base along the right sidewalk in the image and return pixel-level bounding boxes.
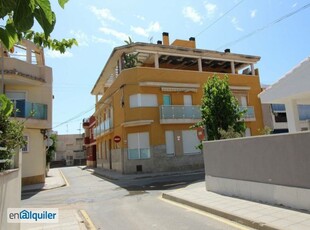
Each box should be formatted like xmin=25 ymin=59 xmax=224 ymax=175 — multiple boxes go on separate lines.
xmin=204 ymin=132 xmax=310 ymax=210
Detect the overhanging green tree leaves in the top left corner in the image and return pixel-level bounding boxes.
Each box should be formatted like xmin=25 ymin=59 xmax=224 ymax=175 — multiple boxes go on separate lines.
xmin=0 ymin=0 xmax=77 ymax=53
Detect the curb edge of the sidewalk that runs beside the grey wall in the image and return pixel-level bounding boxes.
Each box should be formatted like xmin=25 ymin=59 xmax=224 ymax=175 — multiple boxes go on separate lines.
xmin=162 ymin=193 xmax=280 ymax=230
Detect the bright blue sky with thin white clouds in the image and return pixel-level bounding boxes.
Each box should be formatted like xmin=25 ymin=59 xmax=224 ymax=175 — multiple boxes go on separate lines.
xmin=45 ymin=0 xmax=310 ymax=134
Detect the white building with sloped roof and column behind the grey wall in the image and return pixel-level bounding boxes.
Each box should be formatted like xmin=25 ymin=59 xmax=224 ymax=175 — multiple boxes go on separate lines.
xmin=259 ymin=57 xmax=310 ymax=133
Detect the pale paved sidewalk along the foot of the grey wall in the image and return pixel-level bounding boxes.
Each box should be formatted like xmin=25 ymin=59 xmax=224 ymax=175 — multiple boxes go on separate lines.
xmin=162 ymin=182 xmax=310 ymax=230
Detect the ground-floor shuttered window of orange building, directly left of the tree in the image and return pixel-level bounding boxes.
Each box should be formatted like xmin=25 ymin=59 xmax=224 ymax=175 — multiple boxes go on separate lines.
xmin=182 ymin=130 xmax=200 ymax=154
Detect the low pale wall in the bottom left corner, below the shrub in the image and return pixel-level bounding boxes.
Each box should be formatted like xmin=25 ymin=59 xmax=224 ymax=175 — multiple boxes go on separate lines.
xmin=0 ymin=152 xmax=21 ymax=230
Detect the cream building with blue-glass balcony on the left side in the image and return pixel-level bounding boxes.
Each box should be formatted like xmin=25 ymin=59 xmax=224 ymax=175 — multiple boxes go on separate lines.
xmin=0 ymin=40 xmax=53 ymax=185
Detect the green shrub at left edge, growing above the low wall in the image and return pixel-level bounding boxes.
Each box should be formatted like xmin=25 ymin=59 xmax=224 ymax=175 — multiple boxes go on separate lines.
xmin=0 ymin=94 xmax=26 ymax=171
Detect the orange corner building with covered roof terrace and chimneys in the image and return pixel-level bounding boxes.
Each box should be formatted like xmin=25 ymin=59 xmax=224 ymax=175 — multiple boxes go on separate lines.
xmin=91 ymin=33 xmax=263 ymax=173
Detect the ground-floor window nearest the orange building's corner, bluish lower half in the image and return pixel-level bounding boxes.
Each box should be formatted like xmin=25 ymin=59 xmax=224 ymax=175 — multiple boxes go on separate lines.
xmin=127 ymin=132 xmax=150 ymax=160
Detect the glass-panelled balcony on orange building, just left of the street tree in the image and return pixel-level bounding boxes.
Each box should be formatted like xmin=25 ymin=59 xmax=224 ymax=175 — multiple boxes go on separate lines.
xmin=159 ymin=105 xmax=201 ymax=124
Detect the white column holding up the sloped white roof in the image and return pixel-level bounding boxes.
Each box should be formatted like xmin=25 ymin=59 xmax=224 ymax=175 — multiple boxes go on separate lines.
xmin=285 ymin=100 xmax=300 ymax=133
